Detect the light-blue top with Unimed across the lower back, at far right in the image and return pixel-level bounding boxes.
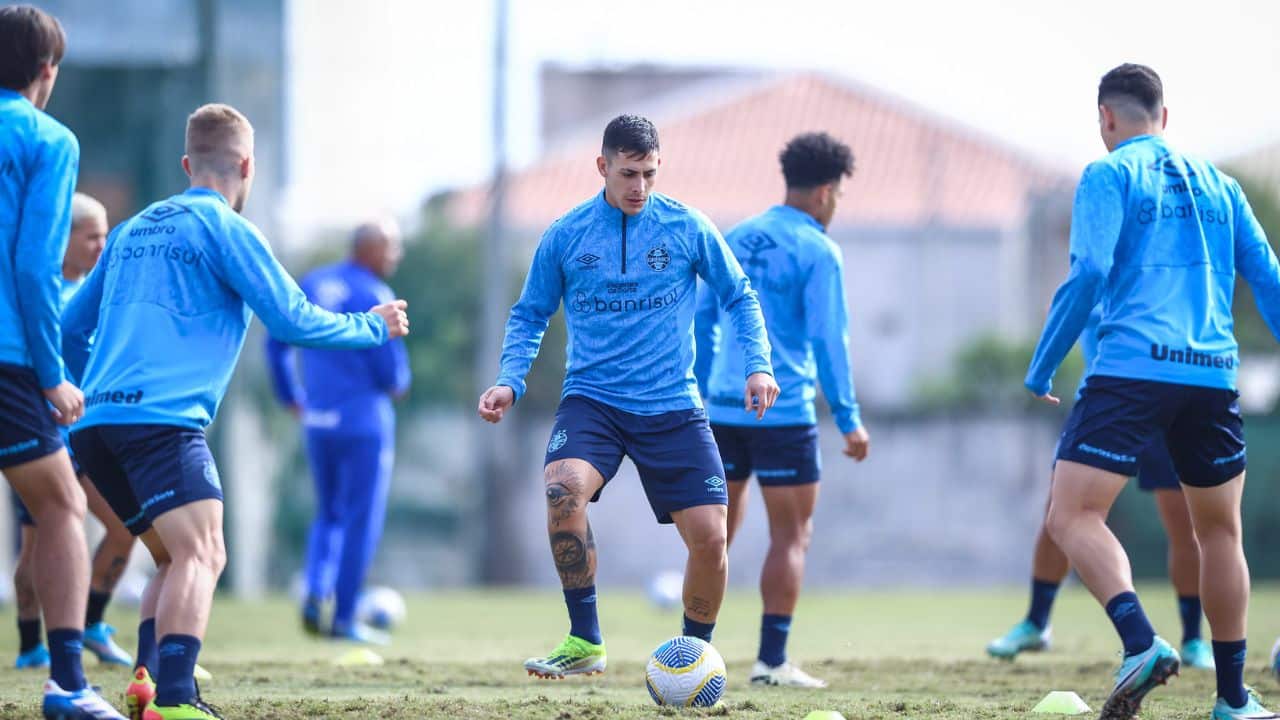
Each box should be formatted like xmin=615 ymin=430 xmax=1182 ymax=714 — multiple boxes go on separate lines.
xmin=1025 ymin=136 xmax=1280 ymax=395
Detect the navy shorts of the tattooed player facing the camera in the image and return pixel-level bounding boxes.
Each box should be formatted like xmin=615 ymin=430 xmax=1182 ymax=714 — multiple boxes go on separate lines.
xmin=544 ymin=395 xmax=728 ymax=523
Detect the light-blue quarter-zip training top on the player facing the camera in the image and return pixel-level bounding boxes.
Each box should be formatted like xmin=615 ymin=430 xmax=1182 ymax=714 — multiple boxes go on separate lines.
xmin=497 ymin=192 xmax=773 ymax=415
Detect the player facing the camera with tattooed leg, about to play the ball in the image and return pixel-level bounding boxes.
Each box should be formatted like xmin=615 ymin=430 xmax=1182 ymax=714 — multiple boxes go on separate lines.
xmin=479 ymin=115 xmax=778 ymax=678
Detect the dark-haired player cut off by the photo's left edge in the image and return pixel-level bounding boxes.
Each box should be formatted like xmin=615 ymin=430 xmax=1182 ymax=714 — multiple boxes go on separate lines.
xmin=0 ymin=5 xmax=120 ymax=719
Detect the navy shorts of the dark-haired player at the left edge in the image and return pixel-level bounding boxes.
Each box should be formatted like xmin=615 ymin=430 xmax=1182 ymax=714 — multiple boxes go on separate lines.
xmin=0 ymin=361 xmax=63 ymax=470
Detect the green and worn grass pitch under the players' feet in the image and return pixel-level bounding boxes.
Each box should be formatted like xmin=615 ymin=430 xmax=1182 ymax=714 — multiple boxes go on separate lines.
xmin=0 ymin=585 xmax=1280 ymax=720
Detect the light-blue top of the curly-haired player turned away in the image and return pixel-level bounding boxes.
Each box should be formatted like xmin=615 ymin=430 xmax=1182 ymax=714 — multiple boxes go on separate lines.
xmin=695 ymin=205 xmax=861 ymax=433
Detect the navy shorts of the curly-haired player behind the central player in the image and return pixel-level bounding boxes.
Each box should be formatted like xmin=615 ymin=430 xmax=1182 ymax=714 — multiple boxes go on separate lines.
xmin=712 ymin=424 xmax=822 ymax=486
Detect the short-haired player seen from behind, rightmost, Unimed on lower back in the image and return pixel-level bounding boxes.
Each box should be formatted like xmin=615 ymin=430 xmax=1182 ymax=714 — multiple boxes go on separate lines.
xmin=1025 ymin=64 xmax=1280 ymax=720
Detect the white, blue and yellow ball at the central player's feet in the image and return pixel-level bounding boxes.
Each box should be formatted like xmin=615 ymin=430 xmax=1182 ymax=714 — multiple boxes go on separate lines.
xmin=644 ymin=637 xmax=724 ymax=707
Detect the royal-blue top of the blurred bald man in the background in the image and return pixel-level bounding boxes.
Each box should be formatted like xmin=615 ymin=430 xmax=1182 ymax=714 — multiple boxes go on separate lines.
xmin=266 ymin=260 xmax=410 ymax=433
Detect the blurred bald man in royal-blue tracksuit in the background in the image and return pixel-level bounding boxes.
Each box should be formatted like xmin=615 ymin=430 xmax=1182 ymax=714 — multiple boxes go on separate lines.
xmin=266 ymin=220 xmax=410 ymax=642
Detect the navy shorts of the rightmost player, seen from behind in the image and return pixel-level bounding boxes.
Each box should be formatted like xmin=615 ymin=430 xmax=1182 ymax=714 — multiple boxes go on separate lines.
xmin=1057 ymin=375 xmax=1244 ymax=487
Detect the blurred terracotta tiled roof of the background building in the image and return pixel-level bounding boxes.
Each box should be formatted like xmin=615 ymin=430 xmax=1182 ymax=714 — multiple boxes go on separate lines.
xmin=451 ymin=74 xmax=1073 ymax=228
